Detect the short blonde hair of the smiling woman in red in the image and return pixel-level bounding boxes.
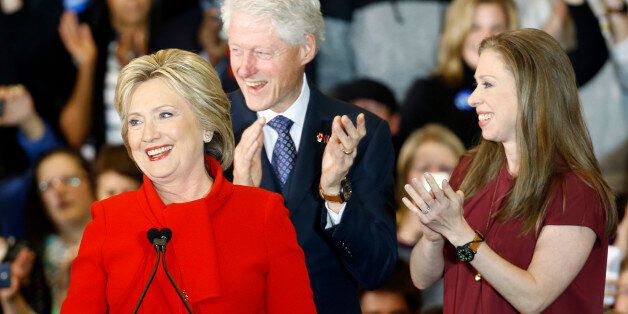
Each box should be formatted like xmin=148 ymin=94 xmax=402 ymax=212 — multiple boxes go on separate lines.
xmin=114 ymin=49 xmax=234 ymax=169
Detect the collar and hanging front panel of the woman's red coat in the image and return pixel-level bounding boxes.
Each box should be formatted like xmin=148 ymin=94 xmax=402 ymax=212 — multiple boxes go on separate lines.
xmin=138 ymin=156 xmax=233 ymax=303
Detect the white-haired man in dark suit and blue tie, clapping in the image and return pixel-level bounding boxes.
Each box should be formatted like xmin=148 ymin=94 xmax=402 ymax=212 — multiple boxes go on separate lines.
xmin=222 ymin=0 xmax=397 ymax=313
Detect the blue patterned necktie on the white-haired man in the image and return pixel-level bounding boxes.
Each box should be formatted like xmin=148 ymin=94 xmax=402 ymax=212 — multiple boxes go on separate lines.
xmin=267 ymin=116 xmax=297 ymax=188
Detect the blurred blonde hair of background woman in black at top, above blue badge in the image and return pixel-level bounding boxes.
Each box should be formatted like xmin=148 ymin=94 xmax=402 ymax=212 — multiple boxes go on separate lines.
xmin=434 ymin=0 xmax=519 ymax=85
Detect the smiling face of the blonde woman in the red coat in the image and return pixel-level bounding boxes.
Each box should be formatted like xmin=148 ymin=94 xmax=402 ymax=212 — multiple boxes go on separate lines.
xmin=124 ymin=78 xmax=205 ymax=182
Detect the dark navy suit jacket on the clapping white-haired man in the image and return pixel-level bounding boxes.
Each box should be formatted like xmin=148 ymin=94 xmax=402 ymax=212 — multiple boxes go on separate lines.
xmin=229 ymin=84 xmax=397 ymax=314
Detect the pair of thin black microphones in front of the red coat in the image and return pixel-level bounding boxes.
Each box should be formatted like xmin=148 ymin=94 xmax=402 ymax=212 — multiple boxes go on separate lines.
xmin=133 ymin=228 xmax=192 ymax=314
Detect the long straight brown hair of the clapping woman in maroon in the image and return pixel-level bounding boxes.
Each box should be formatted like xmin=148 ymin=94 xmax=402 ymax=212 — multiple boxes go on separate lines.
xmin=460 ymin=29 xmax=617 ymax=235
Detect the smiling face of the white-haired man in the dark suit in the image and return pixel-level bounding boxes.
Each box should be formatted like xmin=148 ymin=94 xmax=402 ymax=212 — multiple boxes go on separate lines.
xmin=227 ymin=12 xmax=316 ymax=113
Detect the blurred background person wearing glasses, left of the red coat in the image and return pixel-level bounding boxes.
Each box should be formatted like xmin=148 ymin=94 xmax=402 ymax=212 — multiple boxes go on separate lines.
xmin=26 ymin=149 xmax=94 ymax=313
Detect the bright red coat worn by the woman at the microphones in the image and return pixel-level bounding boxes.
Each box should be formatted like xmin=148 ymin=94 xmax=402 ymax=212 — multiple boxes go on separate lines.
xmin=61 ymin=158 xmax=316 ymax=313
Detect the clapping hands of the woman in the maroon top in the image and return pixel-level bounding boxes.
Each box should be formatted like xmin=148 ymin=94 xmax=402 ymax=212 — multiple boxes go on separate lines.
xmin=404 ymin=173 xmax=475 ymax=246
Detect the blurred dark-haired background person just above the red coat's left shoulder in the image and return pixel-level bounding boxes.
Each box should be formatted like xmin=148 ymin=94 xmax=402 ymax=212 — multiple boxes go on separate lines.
xmin=92 ymin=145 xmax=142 ymax=201
